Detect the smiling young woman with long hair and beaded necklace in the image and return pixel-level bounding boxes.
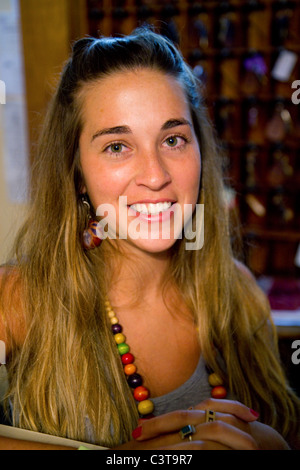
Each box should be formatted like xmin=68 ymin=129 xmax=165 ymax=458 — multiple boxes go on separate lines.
xmin=0 ymin=29 xmax=299 ymax=449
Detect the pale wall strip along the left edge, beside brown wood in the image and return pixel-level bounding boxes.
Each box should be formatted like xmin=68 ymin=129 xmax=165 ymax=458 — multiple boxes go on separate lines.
xmin=0 ymin=0 xmax=28 ymax=263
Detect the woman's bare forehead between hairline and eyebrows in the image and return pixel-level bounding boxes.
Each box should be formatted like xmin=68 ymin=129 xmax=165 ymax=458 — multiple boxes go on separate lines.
xmin=78 ymin=68 xmax=190 ymax=123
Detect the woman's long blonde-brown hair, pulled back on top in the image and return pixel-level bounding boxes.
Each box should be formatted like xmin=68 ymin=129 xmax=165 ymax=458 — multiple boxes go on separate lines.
xmin=3 ymin=29 xmax=298 ymax=446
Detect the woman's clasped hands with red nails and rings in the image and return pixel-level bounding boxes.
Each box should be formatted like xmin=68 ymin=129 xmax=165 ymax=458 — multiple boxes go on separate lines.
xmin=113 ymin=399 xmax=259 ymax=450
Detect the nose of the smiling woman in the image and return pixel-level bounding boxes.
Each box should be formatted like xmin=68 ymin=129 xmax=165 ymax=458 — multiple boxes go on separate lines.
xmin=135 ymin=151 xmax=171 ymax=191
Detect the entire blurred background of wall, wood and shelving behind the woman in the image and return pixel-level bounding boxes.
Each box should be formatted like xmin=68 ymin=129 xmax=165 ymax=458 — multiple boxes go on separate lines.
xmin=0 ymin=0 xmax=300 ymax=387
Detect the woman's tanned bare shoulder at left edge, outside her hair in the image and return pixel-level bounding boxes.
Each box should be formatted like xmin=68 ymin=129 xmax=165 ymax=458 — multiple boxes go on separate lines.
xmin=0 ymin=266 xmax=25 ymax=353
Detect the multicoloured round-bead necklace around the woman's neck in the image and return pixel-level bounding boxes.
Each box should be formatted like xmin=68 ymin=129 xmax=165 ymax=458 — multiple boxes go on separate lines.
xmin=105 ymin=300 xmax=227 ymax=418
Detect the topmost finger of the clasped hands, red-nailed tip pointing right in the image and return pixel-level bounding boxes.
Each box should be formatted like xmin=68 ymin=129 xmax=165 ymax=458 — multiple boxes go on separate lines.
xmin=195 ymin=398 xmax=259 ymax=422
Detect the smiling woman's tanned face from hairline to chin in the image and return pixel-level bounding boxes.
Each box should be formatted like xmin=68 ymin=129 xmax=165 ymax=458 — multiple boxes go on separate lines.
xmin=79 ymin=69 xmax=201 ymax=253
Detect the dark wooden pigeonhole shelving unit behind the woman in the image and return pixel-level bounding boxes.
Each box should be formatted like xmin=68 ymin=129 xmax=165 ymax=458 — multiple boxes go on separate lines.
xmin=87 ymin=0 xmax=300 ymax=276
